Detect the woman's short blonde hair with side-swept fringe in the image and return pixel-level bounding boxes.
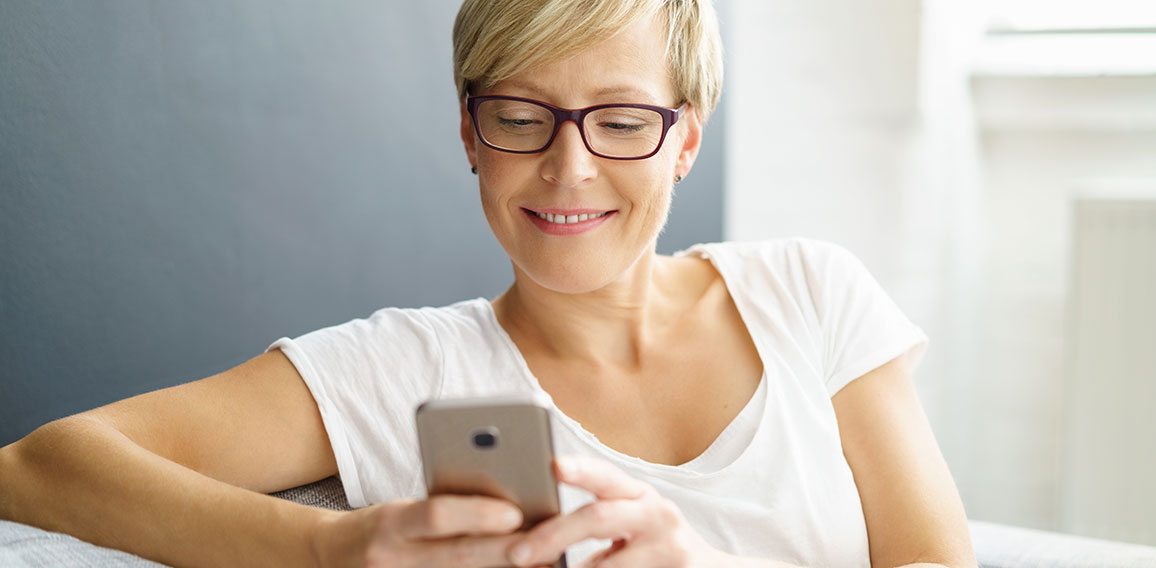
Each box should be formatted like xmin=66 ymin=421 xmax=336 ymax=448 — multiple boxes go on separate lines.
xmin=453 ymin=0 xmax=723 ymax=123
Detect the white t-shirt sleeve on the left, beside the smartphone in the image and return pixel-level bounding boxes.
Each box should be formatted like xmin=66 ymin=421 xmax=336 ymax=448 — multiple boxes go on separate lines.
xmin=269 ymin=309 xmax=443 ymax=507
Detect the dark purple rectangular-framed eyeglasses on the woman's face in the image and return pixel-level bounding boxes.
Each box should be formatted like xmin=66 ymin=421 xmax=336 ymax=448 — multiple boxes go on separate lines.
xmin=466 ymin=95 xmax=687 ymax=160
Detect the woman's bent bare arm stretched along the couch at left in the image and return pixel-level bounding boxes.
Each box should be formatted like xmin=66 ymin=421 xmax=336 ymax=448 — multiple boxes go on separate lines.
xmin=0 ymin=352 xmax=336 ymax=566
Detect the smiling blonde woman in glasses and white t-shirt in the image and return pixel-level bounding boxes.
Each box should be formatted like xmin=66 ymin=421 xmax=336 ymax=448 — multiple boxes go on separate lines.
xmin=0 ymin=0 xmax=975 ymax=567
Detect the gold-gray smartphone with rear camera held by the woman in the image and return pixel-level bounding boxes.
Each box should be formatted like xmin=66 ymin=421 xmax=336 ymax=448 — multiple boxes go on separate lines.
xmin=416 ymin=394 xmax=566 ymax=568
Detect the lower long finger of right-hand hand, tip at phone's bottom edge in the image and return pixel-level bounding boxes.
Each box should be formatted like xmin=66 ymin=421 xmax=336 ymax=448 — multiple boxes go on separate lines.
xmin=510 ymin=500 xmax=651 ymax=566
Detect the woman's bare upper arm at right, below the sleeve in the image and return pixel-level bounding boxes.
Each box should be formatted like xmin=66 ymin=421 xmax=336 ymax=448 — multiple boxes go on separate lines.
xmin=831 ymin=357 xmax=976 ymax=567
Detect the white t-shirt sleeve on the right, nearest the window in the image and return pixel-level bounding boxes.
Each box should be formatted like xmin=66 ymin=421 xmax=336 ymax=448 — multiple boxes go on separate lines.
xmin=799 ymin=241 xmax=927 ymax=397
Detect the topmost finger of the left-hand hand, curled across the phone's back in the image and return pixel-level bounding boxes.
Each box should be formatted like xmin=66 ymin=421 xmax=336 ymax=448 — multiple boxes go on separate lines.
xmin=399 ymin=495 xmax=521 ymax=540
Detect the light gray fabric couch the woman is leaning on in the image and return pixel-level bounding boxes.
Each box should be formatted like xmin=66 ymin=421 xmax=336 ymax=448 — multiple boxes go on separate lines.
xmin=0 ymin=478 xmax=1156 ymax=568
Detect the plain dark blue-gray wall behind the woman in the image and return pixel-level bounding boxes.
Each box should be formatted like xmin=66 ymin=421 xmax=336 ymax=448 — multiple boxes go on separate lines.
xmin=0 ymin=0 xmax=724 ymax=445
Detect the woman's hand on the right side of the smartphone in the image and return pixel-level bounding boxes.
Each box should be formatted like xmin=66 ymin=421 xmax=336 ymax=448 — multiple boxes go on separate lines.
xmin=510 ymin=456 xmax=727 ymax=568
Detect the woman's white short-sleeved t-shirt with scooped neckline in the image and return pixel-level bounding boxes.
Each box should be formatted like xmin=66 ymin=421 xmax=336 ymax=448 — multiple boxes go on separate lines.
xmin=271 ymin=239 xmax=927 ymax=567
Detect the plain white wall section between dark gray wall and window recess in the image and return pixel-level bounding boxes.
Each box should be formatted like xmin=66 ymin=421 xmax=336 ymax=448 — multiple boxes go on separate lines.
xmin=724 ymin=0 xmax=968 ymax=460
